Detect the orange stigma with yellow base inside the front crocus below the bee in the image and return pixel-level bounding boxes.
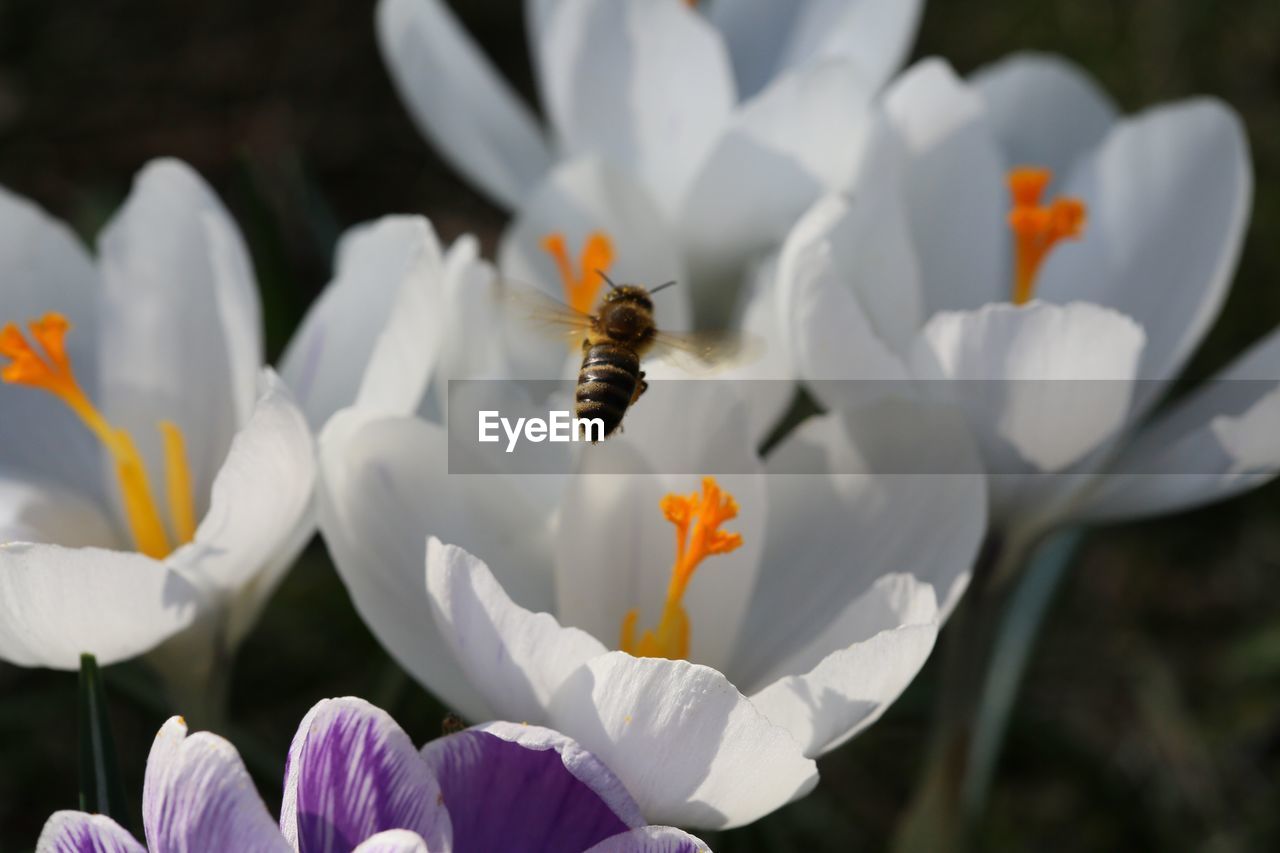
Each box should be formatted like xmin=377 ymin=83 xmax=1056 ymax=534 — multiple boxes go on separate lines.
xmin=618 ymin=476 xmax=742 ymax=661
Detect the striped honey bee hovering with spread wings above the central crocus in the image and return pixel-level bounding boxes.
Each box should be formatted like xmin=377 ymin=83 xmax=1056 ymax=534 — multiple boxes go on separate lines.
xmin=509 ymin=272 xmax=749 ymax=443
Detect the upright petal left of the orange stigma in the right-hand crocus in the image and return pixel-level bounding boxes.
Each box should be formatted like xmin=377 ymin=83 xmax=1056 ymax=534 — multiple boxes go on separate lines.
xmin=880 ymin=59 xmax=1009 ymax=315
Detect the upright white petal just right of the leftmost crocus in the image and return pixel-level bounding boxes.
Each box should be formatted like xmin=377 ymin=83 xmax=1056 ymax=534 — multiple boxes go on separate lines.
xmin=280 ymin=216 xmax=443 ymax=430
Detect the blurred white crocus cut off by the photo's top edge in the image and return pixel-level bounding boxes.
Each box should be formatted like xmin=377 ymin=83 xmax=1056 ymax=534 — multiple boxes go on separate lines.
xmin=378 ymin=0 xmax=923 ymax=306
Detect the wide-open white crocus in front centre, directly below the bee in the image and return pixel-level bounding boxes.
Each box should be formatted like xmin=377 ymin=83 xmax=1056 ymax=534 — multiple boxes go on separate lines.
xmin=320 ymin=326 xmax=986 ymax=827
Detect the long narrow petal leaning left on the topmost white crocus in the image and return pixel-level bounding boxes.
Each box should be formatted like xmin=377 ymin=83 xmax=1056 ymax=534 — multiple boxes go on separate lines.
xmin=378 ymin=0 xmax=552 ymax=206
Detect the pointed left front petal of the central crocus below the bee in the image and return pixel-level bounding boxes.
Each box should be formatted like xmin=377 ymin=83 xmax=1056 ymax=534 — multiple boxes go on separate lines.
xmin=426 ymin=537 xmax=605 ymax=722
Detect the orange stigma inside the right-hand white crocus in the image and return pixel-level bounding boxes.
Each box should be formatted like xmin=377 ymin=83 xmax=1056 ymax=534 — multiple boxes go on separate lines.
xmin=1009 ymin=167 xmax=1085 ymax=305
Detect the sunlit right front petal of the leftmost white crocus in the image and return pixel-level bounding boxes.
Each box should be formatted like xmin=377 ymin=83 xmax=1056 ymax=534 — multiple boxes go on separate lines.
xmin=166 ymin=369 xmax=316 ymax=594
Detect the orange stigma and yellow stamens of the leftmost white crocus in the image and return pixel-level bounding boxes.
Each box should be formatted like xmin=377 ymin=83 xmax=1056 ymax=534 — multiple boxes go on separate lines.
xmin=0 ymin=311 xmax=196 ymax=558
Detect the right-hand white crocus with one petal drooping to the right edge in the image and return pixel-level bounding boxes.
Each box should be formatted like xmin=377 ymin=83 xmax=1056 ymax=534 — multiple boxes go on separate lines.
xmin=781 ymin=56 xmax=1280 ymax=545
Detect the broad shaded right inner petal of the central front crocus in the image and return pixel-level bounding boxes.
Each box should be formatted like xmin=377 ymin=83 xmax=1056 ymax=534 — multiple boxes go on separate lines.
xmin=728 ymin=401 xmax=987 ymax=693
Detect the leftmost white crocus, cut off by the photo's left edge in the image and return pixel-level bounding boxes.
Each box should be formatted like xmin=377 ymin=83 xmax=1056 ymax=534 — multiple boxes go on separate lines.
xmin=0 ymin=160 xmax=315 ymax=689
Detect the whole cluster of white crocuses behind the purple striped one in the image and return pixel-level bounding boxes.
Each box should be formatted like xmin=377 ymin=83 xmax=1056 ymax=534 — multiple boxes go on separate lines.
xmin=0 ymin=0 xmax=1280 ymax=827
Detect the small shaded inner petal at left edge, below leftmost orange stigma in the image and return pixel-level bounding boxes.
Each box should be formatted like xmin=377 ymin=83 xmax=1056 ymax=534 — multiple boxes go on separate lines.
xmin=0 ymin=474 xmax=120 ymax=548
